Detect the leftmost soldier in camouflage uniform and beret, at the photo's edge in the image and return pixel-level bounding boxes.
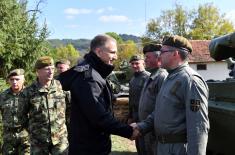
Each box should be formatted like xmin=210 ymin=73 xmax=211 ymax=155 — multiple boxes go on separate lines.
xmin=0 ymin=69 xmax=30 ymax=155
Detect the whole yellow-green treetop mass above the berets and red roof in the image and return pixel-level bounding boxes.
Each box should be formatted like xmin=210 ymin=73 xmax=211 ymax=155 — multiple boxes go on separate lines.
xmin=142 ymin=3 xmax=234 ymax=40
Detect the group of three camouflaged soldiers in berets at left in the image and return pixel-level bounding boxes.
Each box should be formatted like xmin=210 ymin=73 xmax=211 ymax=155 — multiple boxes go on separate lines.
xmin=0 ymin=56 xmax=70 ymax=155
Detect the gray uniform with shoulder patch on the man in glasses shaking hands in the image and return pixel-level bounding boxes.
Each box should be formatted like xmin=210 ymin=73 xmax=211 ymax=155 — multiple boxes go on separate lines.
xmin=138 ymin=63 xmax=209 ymax=155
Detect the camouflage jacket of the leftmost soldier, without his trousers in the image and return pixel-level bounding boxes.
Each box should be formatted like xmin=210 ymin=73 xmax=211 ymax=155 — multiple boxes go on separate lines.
xmin=0 ymin=88 xmax=26 ymax=130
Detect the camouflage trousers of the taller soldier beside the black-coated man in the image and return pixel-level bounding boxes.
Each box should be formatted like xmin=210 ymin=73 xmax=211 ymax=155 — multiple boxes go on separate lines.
xmin=30 ymin=137 xmax=68 ymax=155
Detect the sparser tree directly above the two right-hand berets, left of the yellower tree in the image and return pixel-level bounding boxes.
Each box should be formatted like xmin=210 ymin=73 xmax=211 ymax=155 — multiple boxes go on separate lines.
xmin=142 ymin=4 xmax=190 ymax=41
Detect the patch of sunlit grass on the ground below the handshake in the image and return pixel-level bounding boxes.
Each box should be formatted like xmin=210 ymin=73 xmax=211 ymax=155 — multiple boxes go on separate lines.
xmin=111 ymin=136 xmax=137 ymax=155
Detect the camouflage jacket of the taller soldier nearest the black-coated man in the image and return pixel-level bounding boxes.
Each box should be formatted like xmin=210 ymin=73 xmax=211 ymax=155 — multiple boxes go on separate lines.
xmin=21 ymin=80 xmax=67 ymax=145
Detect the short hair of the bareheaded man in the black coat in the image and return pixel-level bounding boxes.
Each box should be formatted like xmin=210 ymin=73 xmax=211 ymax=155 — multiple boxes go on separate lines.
xmin=90 ymin=34 xmax=116 ymax=51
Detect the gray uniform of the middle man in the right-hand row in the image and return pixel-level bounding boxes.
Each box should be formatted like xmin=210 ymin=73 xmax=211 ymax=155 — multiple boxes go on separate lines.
xmin=139 ymin=68 xmax=168 ymax=155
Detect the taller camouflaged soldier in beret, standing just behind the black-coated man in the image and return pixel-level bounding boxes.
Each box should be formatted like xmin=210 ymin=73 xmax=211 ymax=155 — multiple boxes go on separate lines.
xmin=21 ymin=56 xmax=68 ymax=155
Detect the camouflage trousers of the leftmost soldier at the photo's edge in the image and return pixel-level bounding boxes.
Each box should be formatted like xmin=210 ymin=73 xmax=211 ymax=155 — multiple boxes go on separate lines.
xmin=2 ymin=130 xmax=30 ymax=155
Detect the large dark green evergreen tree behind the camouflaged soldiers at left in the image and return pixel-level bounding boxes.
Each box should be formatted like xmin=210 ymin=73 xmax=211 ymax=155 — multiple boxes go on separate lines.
xmin=0 ymin=0 xmax=49 ymax=81
